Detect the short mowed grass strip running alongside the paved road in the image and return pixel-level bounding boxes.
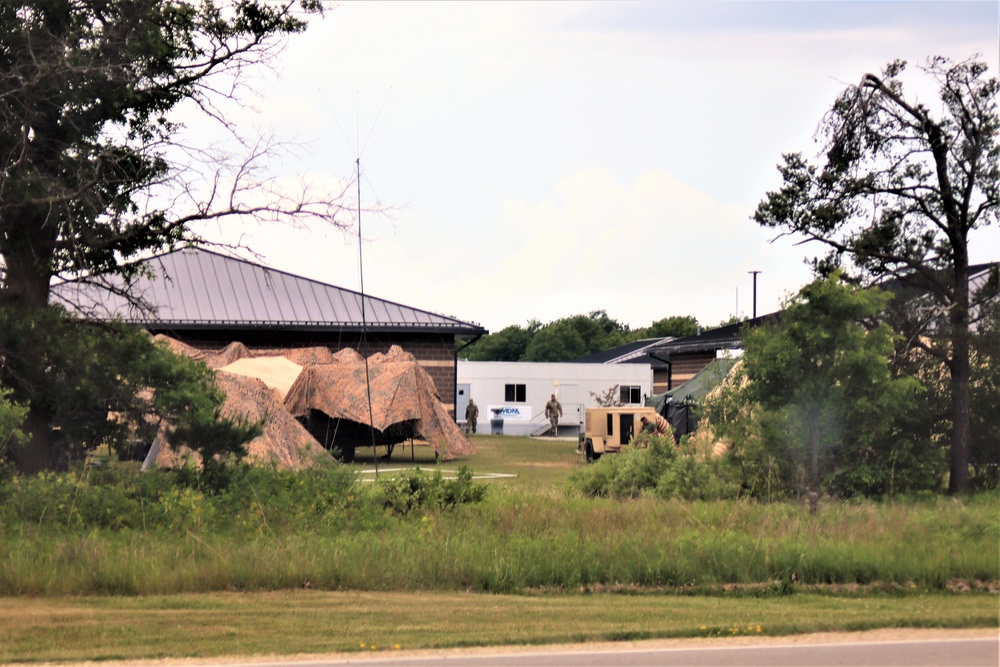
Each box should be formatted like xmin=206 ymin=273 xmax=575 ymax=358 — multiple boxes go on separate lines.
xmin=0 ymin=591 xmax=997 ymax=663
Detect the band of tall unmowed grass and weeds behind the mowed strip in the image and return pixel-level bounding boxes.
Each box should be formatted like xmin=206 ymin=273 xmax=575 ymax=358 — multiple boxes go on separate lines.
xmin=0 ymin=460 xmax=1000 ymax=595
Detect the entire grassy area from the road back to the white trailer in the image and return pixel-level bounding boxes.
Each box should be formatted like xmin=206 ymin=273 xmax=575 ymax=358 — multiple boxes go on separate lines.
xmin=0 ymin=436 xmax=1000 ymax=663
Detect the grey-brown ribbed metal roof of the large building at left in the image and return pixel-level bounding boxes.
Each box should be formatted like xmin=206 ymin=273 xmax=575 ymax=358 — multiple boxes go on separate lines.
xmin=54 ymin=248 xmax=487 ymax=335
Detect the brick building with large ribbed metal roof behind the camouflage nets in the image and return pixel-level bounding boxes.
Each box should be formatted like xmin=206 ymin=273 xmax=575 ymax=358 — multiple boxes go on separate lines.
xmin=53 ymin=248 xmax=488 ymax=418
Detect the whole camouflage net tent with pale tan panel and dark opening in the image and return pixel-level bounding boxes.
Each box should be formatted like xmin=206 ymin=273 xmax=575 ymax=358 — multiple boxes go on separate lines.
xmin=155 ymin=335 xmax=474 ymax=469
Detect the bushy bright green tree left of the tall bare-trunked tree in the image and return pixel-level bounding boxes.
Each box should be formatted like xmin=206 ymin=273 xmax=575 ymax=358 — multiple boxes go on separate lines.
xmin=712 ymin=272 xmax=939 ymax=506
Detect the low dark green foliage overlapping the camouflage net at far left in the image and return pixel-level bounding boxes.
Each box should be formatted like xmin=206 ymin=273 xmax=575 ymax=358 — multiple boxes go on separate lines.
xmin=0 ymin=305 xmax=261 ymax=477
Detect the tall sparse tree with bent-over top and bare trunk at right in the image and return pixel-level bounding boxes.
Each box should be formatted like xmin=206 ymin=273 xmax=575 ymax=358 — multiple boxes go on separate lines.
xmin=754 ymin=58 xmax=1000 ymax=493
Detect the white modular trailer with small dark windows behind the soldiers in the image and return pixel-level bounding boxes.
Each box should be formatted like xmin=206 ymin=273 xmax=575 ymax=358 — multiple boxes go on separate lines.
xmin=455 ymin=359 xmax=653 ymax=436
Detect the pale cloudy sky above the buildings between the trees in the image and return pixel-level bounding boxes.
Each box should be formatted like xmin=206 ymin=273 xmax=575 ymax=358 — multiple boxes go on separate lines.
xmin=191 ymin=0 xmax=1000 ymax=331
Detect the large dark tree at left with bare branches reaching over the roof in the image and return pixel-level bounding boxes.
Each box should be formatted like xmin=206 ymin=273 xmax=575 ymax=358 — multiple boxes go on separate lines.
xmin=0 ymin=0 xmax=340 ymax=471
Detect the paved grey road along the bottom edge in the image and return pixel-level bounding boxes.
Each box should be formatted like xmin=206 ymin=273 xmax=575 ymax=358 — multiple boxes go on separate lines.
xmin=201 ymin=638 xmax=1000 ymax=667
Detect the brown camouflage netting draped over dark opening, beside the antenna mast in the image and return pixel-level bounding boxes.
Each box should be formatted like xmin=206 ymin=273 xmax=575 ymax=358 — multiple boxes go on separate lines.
xmin=285 ymin=345 xmax=475 ymax=460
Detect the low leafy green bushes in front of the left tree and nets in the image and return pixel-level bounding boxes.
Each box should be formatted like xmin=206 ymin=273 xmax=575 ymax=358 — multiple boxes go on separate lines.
xmin=0 ymin=464 xmax=381 ymax=534
